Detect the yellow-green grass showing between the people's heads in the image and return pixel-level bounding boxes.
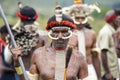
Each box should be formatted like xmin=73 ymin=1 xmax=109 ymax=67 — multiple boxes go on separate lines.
xmin=0 ymin=16 xmax=105 ymax=34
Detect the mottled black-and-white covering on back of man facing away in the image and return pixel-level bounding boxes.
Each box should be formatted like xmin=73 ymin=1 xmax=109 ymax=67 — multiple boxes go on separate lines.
xmin=8 ymin=25 xmax=39 ymax=55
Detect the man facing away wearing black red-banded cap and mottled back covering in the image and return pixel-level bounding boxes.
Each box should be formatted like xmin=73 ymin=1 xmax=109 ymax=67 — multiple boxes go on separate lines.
xmin=4 ymin=6 xmax=45 ymax=74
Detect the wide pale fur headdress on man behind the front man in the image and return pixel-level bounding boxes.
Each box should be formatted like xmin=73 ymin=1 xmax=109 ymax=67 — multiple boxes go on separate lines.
xmin=63 ymin=3 xmax=101 ymax=17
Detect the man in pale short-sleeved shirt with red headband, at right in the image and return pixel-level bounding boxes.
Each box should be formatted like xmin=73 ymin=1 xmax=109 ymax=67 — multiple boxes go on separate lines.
xmin=98 ymin=10 xmax=119 ymax=80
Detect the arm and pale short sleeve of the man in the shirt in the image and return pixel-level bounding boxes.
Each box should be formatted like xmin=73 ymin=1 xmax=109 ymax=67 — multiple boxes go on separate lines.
xmin=98 ymin=32 xmax=113 ymax=80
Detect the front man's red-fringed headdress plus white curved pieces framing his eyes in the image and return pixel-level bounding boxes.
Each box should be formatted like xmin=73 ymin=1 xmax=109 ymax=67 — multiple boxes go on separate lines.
xmin=46 ymin=1 xmax=76 ymax=40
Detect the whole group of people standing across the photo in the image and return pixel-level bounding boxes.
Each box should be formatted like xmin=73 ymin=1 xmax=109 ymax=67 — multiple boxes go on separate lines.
xmin=0 ymin=2 xmax=120 ymax=80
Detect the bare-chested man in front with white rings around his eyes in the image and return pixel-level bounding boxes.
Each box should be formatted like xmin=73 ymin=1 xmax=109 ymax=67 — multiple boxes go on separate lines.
xmin=12 ymin=6 xmax=90 ymax=80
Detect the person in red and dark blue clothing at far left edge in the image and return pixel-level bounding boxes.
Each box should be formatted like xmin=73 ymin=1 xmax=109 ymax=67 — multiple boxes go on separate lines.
xmin=0 ymin=25 xmax=16 ymax=80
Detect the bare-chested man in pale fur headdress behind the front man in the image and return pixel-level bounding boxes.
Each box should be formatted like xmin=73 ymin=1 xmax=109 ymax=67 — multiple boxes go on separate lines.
xmin=68 ymin=0 xmax=101 ymax=80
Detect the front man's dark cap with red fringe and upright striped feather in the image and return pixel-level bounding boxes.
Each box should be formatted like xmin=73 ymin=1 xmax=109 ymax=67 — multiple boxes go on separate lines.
xmin=46 ymin=5 xmax=76 ymax=30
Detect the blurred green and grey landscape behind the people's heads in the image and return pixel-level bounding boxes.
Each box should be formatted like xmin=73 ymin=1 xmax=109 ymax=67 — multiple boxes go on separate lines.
xmin=0 ymin=0 xmax=120 ymax=34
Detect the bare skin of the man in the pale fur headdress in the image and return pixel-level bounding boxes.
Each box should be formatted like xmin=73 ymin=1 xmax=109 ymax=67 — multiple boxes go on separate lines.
xmin=68 ymin=17 xmax=101 ymax=80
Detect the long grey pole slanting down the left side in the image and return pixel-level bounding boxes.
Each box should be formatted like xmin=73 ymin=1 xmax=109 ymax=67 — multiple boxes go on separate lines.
xmin=0 ymin=5 xmax=29 ymax=80
